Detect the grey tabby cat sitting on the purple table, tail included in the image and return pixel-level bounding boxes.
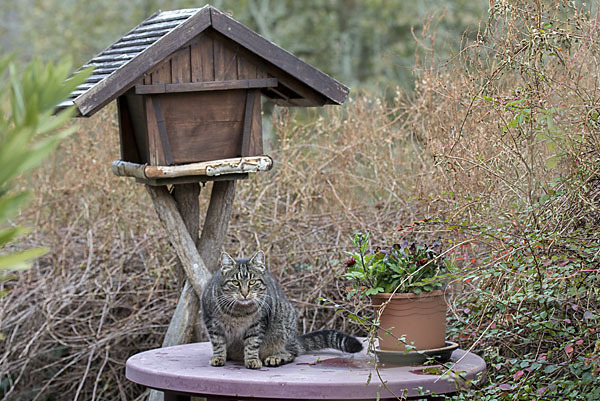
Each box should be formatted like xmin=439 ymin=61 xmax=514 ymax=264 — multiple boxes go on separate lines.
xmin=202 ymin=251 xmax=362 ymax=369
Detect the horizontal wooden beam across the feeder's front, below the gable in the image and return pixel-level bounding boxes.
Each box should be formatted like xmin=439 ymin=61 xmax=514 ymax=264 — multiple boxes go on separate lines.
xmin=135 ymin=78 xmax=278 ymax=95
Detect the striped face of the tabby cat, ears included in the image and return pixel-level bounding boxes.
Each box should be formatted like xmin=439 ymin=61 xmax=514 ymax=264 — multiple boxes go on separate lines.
xmin=221 ymin=251 xmax=266 ymax=308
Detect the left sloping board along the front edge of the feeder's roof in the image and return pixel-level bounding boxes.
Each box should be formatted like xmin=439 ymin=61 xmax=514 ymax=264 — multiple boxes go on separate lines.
xmin=75 ymin=6 xmax=211 ymax=116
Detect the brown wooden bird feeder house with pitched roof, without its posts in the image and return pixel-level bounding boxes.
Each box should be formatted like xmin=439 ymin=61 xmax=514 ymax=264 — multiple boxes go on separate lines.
xmin=60 ymin=6 xmax=348 ymax=185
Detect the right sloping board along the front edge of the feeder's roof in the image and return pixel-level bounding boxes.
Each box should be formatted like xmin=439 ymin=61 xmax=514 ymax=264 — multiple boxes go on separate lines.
xmin=211 ymin=8 xmax=349 ymax=104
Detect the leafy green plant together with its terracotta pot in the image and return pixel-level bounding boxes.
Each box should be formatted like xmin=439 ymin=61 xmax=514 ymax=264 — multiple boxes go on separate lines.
xmin=344 ymin=233 xmax=450 ymax=352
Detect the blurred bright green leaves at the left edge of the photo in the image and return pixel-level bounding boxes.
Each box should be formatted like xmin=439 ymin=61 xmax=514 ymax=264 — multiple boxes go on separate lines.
xmin=0 ymin=58 xmax=91 ymax=280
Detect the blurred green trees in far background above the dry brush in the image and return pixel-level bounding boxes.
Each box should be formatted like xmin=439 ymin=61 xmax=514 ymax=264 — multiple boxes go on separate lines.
xmin=0 ymin=0 xmax=488 ymax=87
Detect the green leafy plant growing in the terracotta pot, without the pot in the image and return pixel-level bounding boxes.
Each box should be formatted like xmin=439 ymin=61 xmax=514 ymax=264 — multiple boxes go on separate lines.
xmin=344 ymin=232 xmax=451 ymax=296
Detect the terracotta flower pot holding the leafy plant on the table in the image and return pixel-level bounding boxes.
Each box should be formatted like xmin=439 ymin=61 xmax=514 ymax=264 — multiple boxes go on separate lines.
xmin=371 ymin=291 xmax=447 ymax=351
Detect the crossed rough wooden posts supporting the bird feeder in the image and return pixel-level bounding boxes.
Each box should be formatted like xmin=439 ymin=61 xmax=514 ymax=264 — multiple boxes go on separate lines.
xmin=146 ymin=180 xmax=236 ymax=401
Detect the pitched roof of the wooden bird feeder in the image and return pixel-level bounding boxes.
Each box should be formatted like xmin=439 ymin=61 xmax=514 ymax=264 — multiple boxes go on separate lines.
xmin=59 ymin=5 xmax=349 ymax=117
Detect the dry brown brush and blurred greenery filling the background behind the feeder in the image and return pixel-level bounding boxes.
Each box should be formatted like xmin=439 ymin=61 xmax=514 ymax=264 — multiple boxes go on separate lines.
xmin=0 ymin=0 xmax=600 ymax=400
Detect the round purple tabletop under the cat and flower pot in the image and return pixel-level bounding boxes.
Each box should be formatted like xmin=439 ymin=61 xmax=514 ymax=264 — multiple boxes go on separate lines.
xmin=126 ymin=342 xmax=485 ymax=401
